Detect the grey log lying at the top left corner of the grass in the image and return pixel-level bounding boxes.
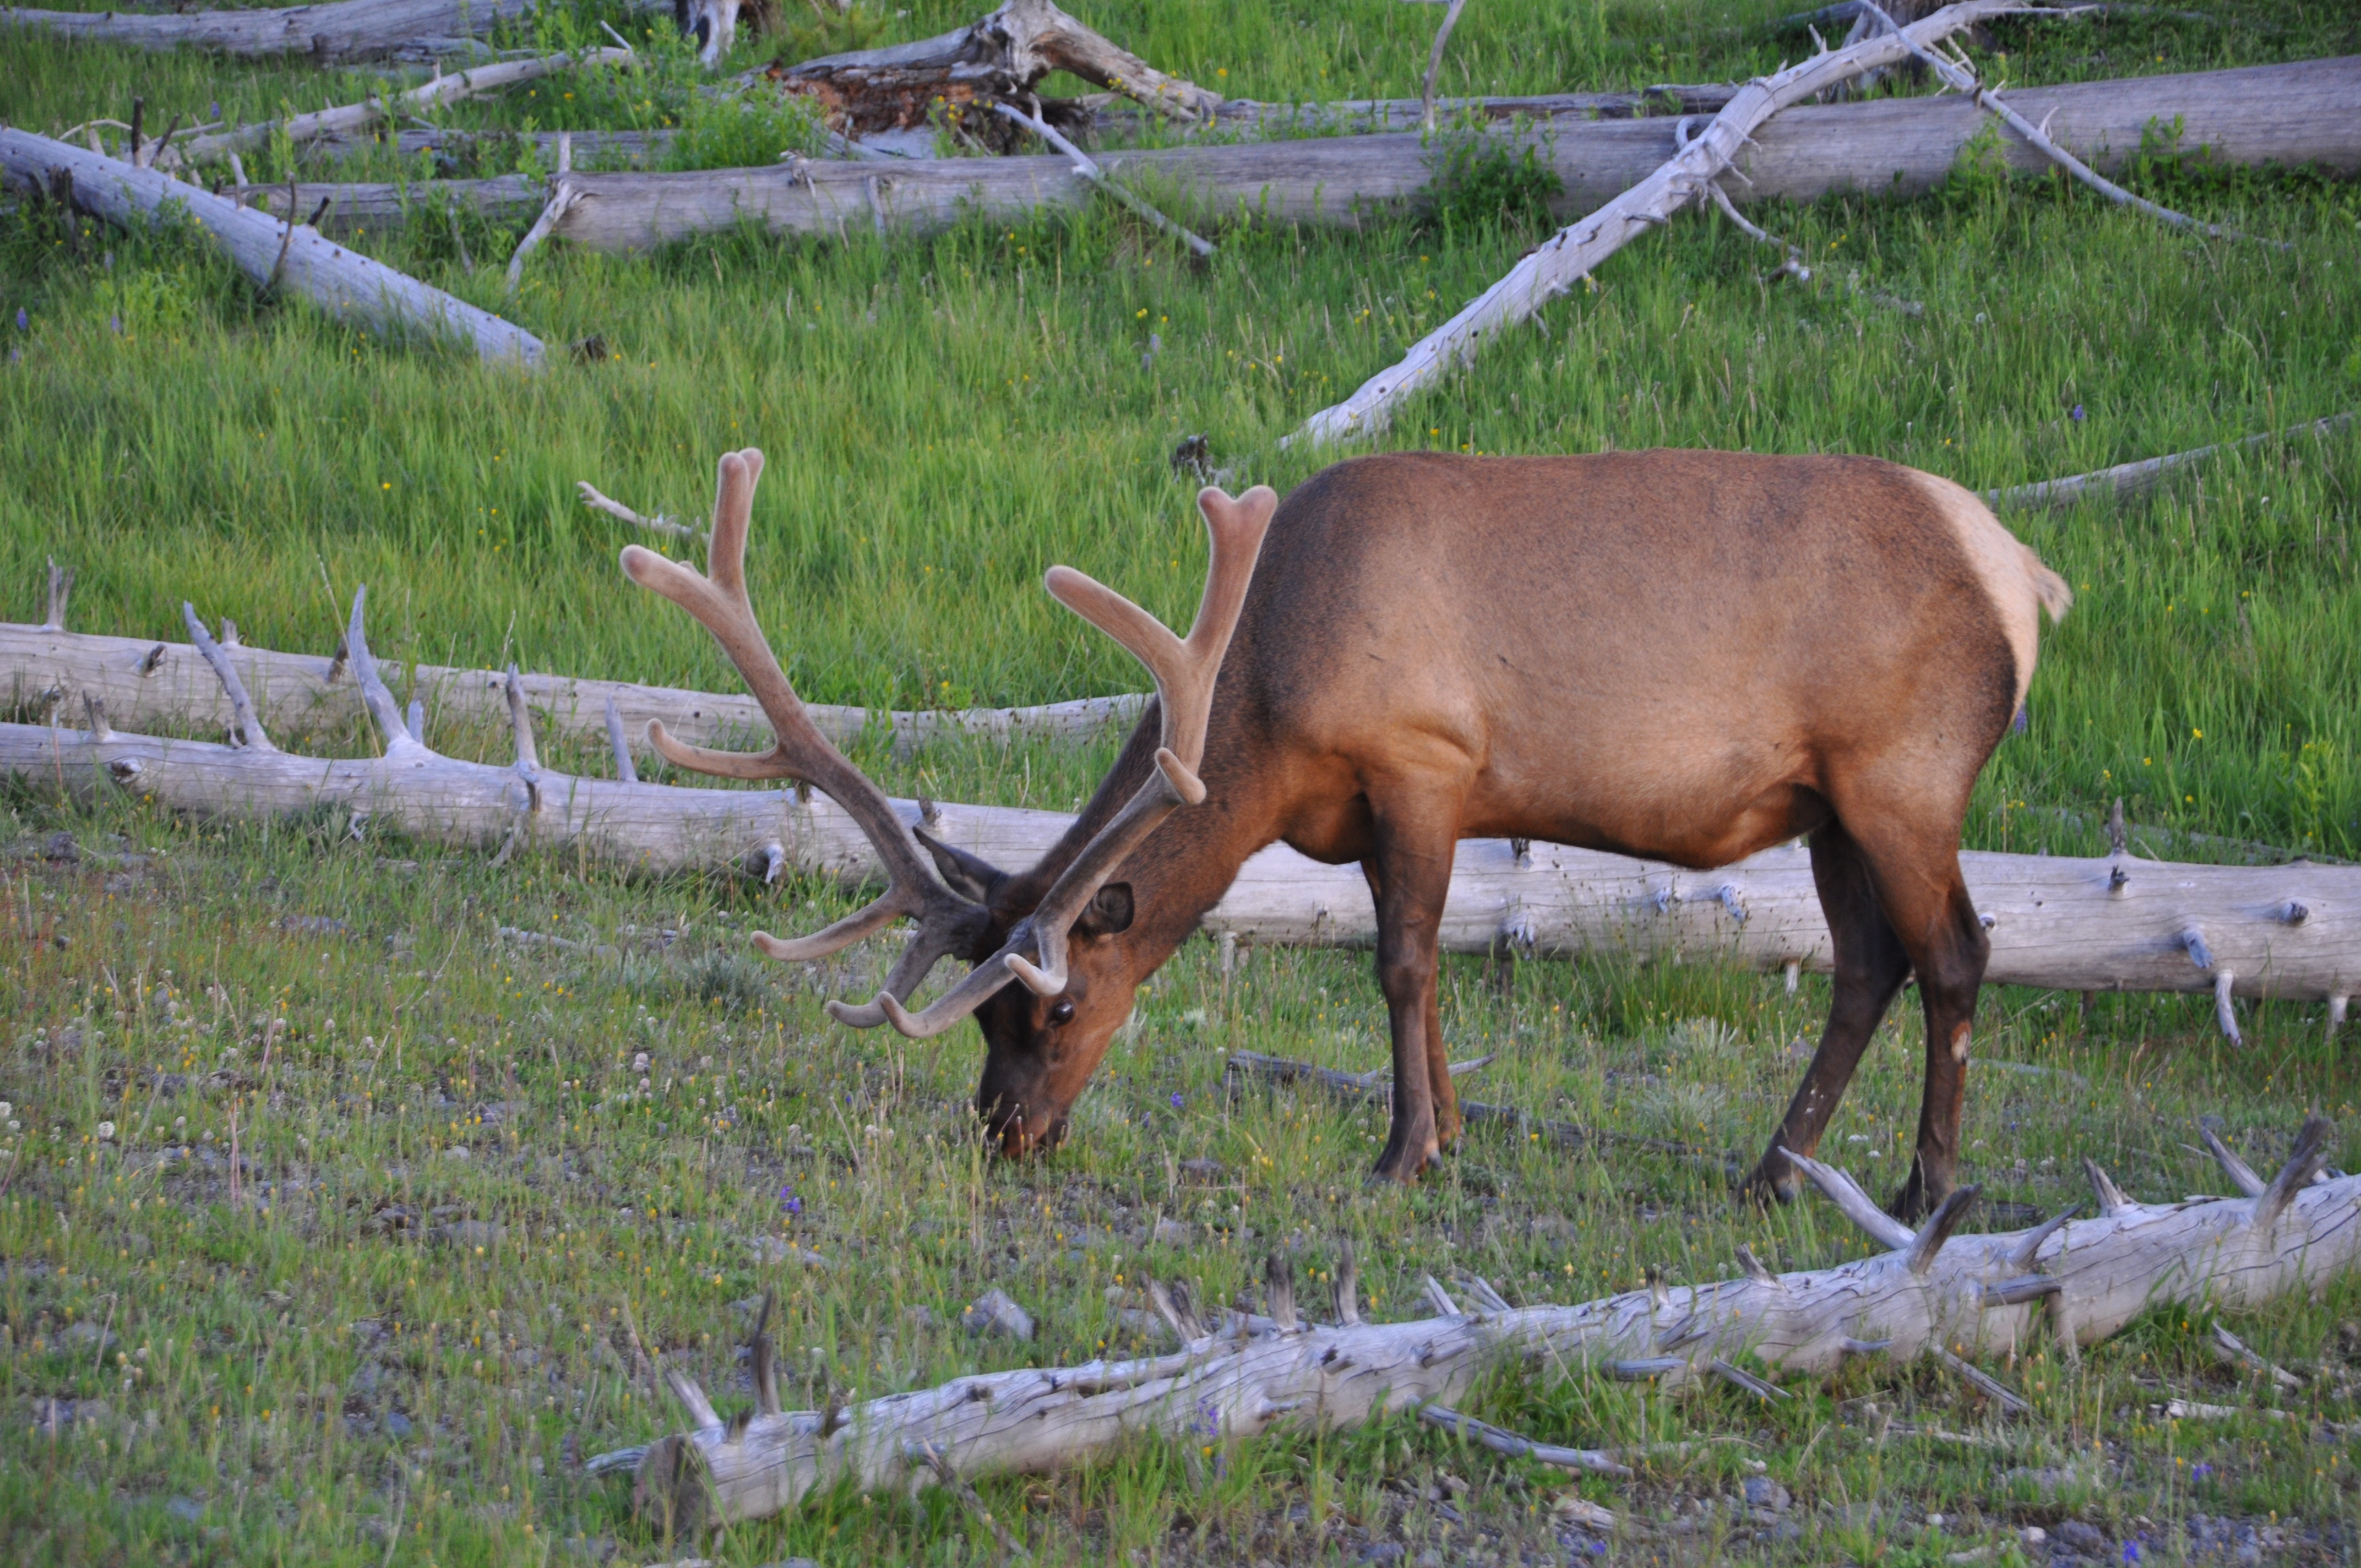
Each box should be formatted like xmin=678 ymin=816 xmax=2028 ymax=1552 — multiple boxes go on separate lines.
xmin=0 ymin=0 xmax=538 ymax=64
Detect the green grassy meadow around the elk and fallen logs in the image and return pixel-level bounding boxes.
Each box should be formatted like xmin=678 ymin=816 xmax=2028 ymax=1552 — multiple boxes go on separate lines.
xmin=0 ymin=0 xmax=2361 ymax=1568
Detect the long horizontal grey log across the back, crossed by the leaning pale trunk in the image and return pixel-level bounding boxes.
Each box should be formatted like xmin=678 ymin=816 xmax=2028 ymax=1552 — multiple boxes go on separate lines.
xmin=189 ymin=57 xmax=2361 ymax=251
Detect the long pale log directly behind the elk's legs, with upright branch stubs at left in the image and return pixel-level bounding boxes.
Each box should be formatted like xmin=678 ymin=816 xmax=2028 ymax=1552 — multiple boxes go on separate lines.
xmin=0 ymin=597 xmax=2361 ymax=1039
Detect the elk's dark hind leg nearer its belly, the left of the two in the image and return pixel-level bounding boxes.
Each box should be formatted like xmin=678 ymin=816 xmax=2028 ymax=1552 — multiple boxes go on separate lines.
xmin=1745 ymin=822 xmax=1910 ymax=1202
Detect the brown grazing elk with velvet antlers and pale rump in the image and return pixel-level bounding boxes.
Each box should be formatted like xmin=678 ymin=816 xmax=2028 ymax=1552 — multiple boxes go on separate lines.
xmin=623 ymin=451 xmax=2071 ymax=1216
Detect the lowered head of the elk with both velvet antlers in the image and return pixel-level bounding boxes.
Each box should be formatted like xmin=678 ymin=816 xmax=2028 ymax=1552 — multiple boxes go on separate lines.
xmin=623 ymin=449 xmax=1280 ymax=1155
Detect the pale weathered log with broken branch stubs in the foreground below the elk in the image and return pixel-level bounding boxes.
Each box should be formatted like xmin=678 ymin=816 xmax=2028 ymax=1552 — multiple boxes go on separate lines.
xmin=592 ymin=1117 xmax=2361 ymax=1530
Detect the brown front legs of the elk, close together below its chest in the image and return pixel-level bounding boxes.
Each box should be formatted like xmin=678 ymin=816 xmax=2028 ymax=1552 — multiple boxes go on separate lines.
xmin=1362 ymin=801 xmax=1459 ymax=1181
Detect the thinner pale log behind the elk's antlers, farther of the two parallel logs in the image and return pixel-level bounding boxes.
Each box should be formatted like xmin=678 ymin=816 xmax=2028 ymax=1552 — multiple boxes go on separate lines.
xmin=0 ymin=618 xmax=1147 ymax=753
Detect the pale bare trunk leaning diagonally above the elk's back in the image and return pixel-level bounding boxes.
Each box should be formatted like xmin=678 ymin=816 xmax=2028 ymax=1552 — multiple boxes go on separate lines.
xmin=1287 ymin=0 xmax=2019 ymax=447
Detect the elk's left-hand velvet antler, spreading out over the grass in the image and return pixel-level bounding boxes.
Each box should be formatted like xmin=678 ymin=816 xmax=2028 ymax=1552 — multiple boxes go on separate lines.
xmin=623 ymin=447 xmax=982 ymax=1027
